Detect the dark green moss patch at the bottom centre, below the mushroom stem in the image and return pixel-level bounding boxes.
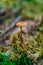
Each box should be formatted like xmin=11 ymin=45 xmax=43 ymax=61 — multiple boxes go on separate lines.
xmin=15 ymin=53 xmax=33 ymax=65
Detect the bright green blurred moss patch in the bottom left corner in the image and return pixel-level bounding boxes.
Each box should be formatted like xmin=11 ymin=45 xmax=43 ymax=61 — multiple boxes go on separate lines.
xmin=0 ymin=54 xmax=15 ymax=65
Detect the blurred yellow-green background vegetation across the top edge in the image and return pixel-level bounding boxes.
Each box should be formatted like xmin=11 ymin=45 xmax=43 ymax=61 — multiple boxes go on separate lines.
xmin=0 ymin=0 xmax=43 ymax=17
